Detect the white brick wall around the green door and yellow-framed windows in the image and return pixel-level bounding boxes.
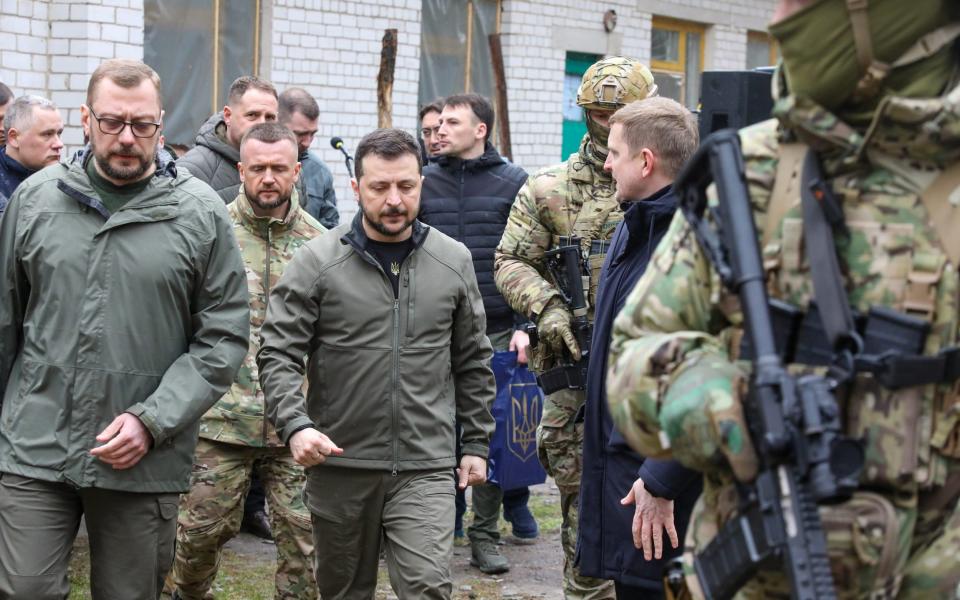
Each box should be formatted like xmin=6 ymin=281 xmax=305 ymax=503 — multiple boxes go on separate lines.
xmin=502 ymin=0 xmax=776 ymax=177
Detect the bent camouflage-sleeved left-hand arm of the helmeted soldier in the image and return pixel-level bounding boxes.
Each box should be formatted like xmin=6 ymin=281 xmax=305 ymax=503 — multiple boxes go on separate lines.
xmin=494 ymin=177 xmax=560 ymax=317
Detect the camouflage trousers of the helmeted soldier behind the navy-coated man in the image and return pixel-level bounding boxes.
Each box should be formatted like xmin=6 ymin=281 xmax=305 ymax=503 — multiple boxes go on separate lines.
xmin=537 ymin=390 xmax=616 ymax=600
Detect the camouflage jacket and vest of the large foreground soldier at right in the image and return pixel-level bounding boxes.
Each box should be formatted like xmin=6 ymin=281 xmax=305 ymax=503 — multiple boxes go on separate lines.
xmin=607 ymin=79 xmax=960 ymax=597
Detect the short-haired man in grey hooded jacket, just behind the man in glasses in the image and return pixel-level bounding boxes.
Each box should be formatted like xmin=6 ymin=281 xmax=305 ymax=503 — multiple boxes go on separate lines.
xmin=177 ymin=75 xmax=278 ymax=204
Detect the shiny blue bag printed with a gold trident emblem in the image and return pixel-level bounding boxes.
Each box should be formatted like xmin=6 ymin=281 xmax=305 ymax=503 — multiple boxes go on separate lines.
xmin=488 ymin=352 xmax=547 ymax=490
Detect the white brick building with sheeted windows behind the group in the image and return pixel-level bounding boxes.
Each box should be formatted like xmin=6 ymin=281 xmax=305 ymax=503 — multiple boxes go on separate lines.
xmin=0 ymin=0 xmax=776 ymax=217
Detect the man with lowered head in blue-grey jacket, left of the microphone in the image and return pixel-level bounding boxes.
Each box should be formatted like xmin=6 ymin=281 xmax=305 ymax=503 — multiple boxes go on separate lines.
xmin=279 ymin=88 xmax=340 ymax=229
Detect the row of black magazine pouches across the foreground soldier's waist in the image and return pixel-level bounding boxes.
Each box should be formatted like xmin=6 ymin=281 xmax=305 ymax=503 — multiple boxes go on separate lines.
xmin=740 ymin=300 xmax=960 ymax=389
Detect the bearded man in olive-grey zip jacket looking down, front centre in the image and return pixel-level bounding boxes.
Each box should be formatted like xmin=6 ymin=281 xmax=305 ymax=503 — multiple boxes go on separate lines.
xmin=257 ymin=129 xmax=495 ymax=600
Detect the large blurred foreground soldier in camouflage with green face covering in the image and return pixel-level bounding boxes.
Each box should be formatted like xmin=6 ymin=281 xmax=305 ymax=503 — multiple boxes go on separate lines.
xmin=607 ymin=0 xmax=960 ymax=599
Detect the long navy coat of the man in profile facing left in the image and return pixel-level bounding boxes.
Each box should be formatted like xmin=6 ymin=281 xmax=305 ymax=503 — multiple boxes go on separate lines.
xmin=577 ymin=188 xmax=702 ymax=590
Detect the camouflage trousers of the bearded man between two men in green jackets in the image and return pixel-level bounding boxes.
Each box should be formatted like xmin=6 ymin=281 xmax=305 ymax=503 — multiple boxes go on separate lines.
xmin=171 ymin=438 xmax=317 ymax=600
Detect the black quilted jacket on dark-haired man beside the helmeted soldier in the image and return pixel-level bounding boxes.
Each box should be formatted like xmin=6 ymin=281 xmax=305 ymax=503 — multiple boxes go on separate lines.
xmin=419 ymin=142 xmax=527 ymax=332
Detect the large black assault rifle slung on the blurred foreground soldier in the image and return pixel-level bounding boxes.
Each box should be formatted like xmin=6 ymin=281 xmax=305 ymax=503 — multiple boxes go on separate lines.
xmin=674 ymin=130 xmax=863 ymax=600
